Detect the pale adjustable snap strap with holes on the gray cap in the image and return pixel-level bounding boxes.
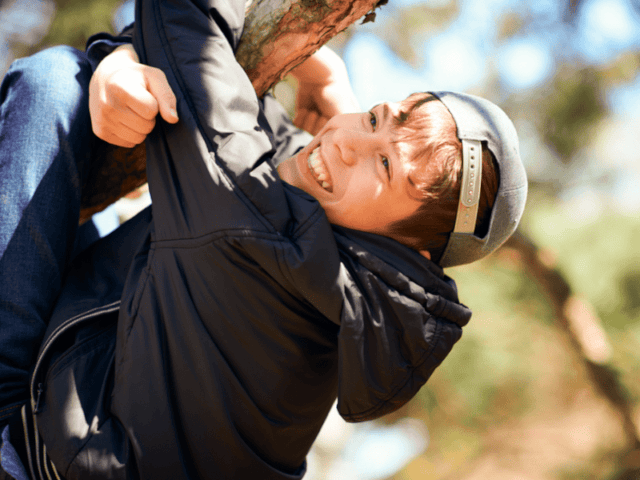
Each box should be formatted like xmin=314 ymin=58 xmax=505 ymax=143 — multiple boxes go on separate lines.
xmin=453 ymin=140 xmax=482 ymax=233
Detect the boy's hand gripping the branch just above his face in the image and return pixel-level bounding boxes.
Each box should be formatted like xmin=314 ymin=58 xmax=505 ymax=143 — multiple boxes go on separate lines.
xmin=291 ymin=47 xmax=360 ymax=135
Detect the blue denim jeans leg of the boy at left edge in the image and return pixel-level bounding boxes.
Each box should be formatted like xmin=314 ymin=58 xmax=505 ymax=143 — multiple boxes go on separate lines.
xmin=0 ymin=47 xmax=97 ymax=428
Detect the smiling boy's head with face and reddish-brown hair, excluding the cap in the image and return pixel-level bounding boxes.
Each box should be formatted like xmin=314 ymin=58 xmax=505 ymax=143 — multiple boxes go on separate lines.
xmin=278 ymin=93 xmax=498 ymax=262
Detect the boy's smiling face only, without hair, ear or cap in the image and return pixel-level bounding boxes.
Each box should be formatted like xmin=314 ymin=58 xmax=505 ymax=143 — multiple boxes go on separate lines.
xmin=278 ymin=103 xmax=438 ymax=234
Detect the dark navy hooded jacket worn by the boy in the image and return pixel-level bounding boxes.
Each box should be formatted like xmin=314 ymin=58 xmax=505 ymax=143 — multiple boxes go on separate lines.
xmin=26 ymin=0 xmax=470 ymax=480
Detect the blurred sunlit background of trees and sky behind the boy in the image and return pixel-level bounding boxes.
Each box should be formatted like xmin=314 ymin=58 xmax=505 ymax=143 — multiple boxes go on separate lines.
xmin=0 ymin=0 xmax=640 ymax=480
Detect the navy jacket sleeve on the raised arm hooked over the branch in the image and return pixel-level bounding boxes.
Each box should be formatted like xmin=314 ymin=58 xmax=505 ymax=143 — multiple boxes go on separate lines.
xmin=133 ymin=0 xmax=296 ymax=240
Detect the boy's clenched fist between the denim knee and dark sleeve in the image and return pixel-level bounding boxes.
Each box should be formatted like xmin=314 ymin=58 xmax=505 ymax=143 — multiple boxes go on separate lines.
xmin=89 ymin=45 xmax=178 ymax=148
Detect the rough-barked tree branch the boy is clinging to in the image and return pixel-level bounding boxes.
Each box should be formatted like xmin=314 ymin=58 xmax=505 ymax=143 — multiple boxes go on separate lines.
xmin=80 ymin=0 xmax=386 ymax=223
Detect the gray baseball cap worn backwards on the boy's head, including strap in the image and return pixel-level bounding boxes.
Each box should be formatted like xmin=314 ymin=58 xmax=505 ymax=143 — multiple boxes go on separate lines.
xmin=430 ymin=92 xmax=527 ymax=267
